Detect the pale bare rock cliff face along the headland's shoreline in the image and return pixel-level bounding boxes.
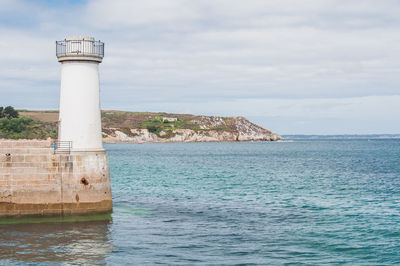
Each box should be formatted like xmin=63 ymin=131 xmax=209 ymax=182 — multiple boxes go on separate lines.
xmin=103 ymin=116 xmax=283 ymax=143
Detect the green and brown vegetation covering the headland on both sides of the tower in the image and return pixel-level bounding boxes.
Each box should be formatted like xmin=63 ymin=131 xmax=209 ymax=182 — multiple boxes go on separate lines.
xmin=0 ymin=109 xmax=239 ymax=139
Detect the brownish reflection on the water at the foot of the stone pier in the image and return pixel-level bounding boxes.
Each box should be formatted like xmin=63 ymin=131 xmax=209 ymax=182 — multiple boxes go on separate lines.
xmin=0 ymin=216 xmax=113 ymax=264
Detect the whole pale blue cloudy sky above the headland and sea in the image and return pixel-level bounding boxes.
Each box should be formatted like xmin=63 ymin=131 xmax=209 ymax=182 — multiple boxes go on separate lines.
xmin=0 ymin=0 xmax=400 ymax=134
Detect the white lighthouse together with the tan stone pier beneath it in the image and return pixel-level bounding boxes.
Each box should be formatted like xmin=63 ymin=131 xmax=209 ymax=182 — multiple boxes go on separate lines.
xmin=0 ymin=36 xmax=112 ymax=216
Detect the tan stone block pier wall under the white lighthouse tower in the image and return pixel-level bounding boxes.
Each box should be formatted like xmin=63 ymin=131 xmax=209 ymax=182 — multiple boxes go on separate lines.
xmin=0 ymin=140 xmax=112 ymax=216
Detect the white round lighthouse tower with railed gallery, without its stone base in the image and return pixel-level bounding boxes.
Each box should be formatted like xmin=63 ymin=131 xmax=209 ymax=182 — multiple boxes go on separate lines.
xmin=56 ymin=36 xmax=104 ymax=152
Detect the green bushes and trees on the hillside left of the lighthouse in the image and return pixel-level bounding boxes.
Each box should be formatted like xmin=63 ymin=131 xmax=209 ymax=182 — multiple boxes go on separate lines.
xmin=0 ymin=106 xmax=57 ymax=139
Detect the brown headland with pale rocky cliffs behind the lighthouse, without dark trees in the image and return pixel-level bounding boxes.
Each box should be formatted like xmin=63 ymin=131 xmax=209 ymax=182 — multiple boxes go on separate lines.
xmin=18 ymin=110 xmax=282 ymax=143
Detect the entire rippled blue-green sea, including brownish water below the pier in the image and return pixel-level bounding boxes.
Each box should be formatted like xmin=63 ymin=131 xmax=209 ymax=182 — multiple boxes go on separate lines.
xmin=0 ymin=139 xmax=400 ymax=265
